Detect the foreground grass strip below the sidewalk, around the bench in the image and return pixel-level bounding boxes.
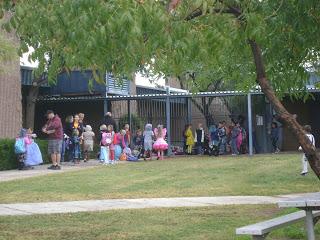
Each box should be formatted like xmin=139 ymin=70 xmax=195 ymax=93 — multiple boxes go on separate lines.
xmin=0 ymin=205 xmax=320 ymax=240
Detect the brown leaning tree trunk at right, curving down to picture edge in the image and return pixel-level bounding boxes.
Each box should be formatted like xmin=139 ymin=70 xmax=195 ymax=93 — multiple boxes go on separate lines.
xmin=249 ymin=40 xmax=320 ymax=180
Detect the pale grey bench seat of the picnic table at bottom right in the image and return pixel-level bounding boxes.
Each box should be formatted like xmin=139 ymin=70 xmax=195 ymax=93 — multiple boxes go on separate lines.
xmin=236 ymin=211 xmax=320 ymax=240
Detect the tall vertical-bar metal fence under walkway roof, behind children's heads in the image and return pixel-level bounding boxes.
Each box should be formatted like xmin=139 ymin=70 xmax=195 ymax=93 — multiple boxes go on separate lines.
xmin=105 ymin=90 xmax=261 ymax=154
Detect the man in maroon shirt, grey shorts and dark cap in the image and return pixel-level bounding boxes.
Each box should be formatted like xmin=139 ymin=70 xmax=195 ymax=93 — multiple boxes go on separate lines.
xmin=42 ymin=110 xmax=63 ymax=170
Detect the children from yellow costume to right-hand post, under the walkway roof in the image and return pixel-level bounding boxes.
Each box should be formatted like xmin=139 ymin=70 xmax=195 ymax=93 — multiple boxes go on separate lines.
xmin=183 ymin=121 xmax=247 ymax=155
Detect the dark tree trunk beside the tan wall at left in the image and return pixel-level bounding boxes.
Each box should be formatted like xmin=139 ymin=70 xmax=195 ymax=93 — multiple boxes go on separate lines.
xmin=25 ymin=86 xmax=39 ymax=129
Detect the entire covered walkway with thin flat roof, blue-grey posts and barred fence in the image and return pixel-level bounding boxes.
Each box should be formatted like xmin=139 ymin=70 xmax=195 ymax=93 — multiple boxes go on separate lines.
xmin=38 ymin=90 xmax=272 ymax=154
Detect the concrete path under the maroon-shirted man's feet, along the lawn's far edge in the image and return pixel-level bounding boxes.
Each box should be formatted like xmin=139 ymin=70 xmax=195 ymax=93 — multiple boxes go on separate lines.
xmin=0 ymin=160 xmax=124 ymax=182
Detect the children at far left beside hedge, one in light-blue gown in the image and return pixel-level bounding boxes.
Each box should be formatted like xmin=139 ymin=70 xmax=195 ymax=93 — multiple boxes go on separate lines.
xmin=14 ymin=128 xmax=43 ymax=170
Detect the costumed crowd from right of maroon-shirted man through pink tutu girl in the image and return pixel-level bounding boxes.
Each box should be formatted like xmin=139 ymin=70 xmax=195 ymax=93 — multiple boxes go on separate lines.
xmin=62 ymin=111 xmax=168 ymax=164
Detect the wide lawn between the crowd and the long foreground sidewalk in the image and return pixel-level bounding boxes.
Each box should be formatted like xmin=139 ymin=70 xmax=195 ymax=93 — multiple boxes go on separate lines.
xmin=0 ymin=154 xmax=320 ymax=203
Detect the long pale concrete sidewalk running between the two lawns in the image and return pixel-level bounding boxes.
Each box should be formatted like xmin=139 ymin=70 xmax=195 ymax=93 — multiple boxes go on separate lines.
xmin=0 ymin=194 xmax=303 ymax=216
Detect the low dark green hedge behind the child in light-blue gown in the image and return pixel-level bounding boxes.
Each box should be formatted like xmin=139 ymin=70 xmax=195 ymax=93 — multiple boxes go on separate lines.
xmin=0 ymin=139 xmax=50 ymax=170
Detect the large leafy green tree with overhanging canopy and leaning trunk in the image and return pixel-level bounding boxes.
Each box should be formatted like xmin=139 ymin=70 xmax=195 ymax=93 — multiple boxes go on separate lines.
xmin=1 ymin=0 xmax=320 ymax=177
